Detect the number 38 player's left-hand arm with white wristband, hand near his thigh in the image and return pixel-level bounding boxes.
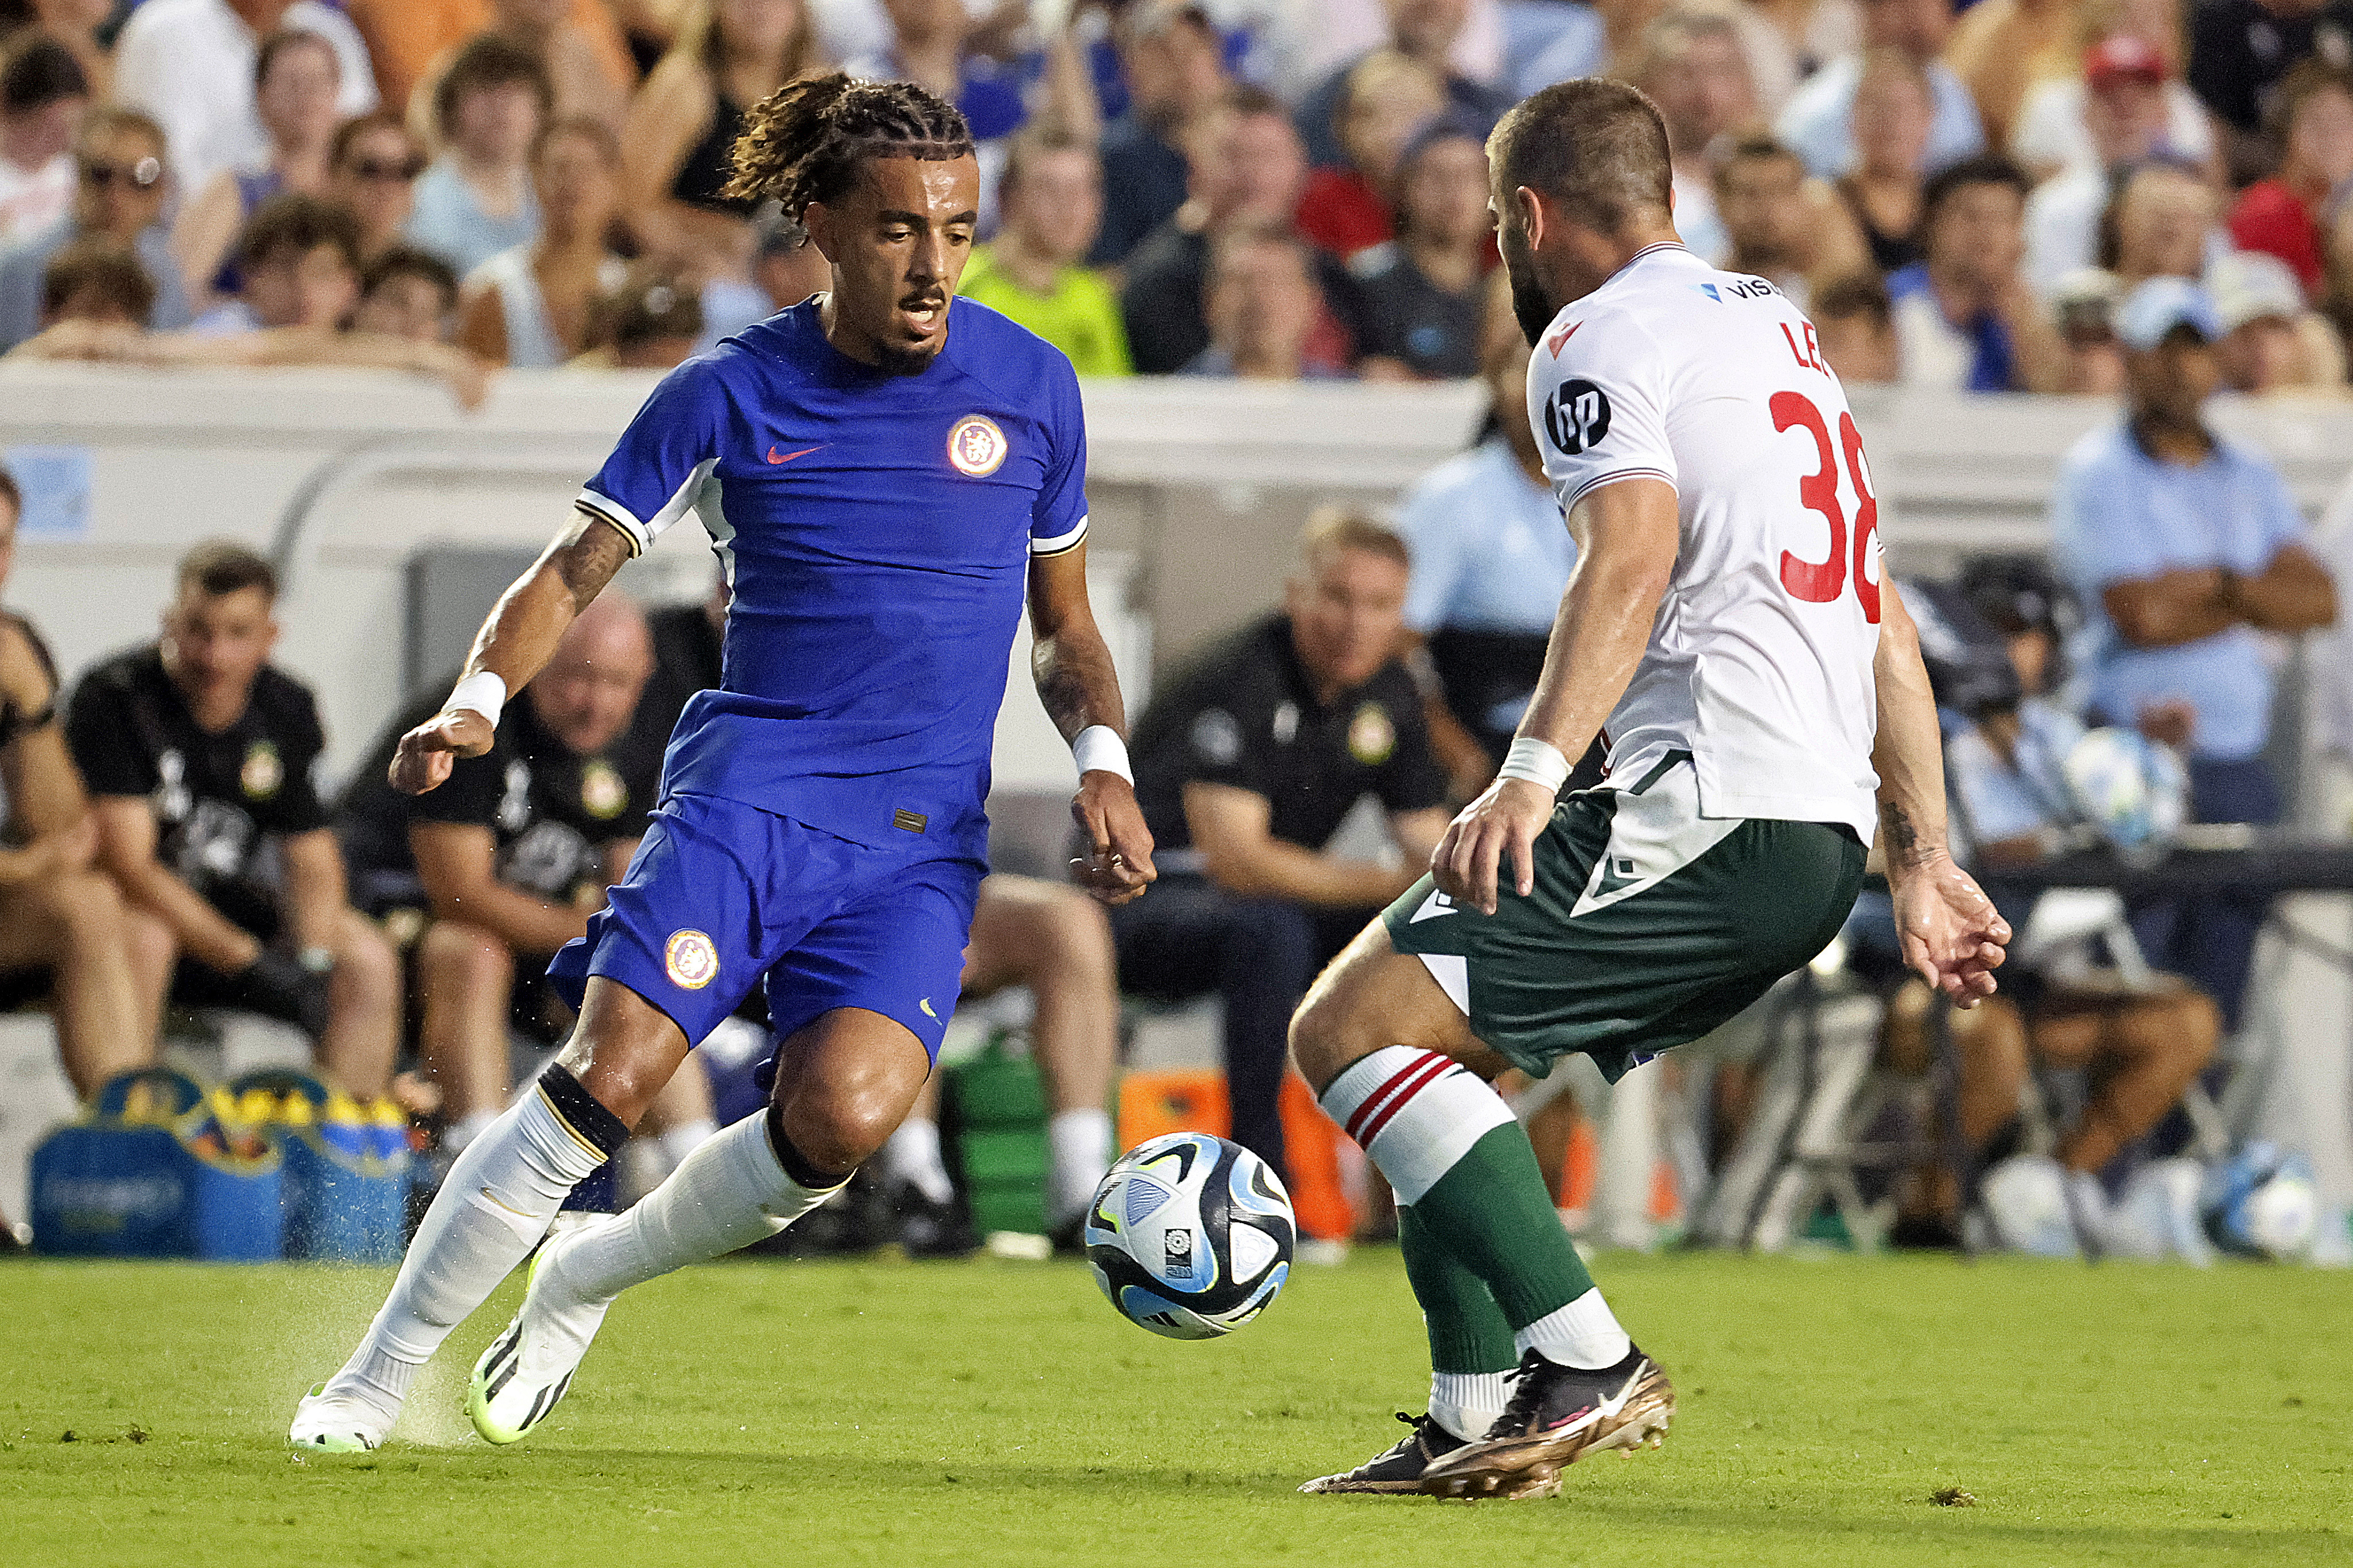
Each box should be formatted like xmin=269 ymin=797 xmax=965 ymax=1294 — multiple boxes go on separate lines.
xmin=1431 ymin=480 xmax=1680 ymax=915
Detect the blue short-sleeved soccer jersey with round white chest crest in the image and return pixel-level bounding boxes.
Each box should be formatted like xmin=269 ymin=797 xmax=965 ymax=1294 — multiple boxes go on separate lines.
xmin=579 ymin=298 xmax=1087 ymax=855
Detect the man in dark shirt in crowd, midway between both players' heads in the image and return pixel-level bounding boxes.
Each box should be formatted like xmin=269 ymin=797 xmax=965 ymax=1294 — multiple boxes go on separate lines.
xmin=1120 ymin=87 xmax=1348 ymax=376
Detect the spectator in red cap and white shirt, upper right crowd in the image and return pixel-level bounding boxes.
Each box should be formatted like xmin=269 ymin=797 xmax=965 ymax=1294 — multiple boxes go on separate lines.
xmin=2009 ymin=10 xmax=2219 ymax=178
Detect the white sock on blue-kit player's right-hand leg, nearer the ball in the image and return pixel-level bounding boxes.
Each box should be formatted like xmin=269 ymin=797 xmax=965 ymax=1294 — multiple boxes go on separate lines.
xmin=539 ymin=1112 xmax=847 ymax=1307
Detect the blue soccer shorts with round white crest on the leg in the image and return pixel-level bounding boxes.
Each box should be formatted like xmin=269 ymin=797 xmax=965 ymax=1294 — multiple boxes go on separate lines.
xmin=548 ymin=795 xmax=988 ymax=1060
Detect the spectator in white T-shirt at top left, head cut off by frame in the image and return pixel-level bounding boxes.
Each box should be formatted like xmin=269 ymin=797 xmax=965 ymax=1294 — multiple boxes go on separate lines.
xmin=115 ymin=0 xmax=376 ymax=193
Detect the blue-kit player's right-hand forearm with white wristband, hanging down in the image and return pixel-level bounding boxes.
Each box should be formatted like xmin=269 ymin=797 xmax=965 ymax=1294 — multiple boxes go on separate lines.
xmin=1028 ymin=543 xmax=1160 ymax=902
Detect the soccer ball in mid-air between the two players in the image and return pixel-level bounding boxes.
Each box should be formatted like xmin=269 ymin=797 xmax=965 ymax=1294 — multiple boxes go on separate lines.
xmin=1085 ymin=1133 xmax=1299 ymax=1340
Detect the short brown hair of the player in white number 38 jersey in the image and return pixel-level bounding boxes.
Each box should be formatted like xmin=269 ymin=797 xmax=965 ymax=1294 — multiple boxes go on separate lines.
xmin=1487 ymin=75 xmax=1673 ymax=235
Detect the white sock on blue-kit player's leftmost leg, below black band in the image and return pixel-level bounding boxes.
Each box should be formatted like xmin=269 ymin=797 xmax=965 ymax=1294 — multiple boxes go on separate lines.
xmin=327 ymin=1088 xmax=605 ymax=1413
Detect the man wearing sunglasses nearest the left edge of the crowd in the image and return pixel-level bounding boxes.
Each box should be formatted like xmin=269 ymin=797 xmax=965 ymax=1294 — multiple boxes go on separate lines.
xmin=0 ymin=108 xmax=188 ymax=351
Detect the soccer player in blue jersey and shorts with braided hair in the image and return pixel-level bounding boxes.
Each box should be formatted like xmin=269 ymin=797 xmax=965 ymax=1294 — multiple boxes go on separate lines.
xmin=289 ymin=75 xmax=1153 ymax=1453
